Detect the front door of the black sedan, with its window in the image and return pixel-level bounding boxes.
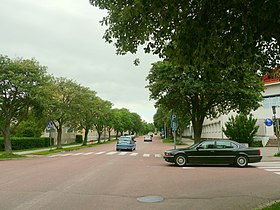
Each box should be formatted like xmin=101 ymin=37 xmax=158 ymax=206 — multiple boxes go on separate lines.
xmin=188 ymin=141 xmax=216 ymax=164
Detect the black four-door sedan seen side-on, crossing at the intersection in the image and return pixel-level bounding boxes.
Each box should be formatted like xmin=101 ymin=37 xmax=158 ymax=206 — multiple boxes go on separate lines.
xmin=164 ymin=140 xmax=262 ymax=167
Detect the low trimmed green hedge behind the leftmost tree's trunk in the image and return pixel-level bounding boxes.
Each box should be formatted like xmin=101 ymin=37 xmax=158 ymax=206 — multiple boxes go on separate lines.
xmin=0 ymin=137 xmax=54 ymax=151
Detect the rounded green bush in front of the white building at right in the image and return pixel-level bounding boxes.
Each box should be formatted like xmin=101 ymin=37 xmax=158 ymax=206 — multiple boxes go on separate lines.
xmin=223 ymin=113 xmax=259 ymax=146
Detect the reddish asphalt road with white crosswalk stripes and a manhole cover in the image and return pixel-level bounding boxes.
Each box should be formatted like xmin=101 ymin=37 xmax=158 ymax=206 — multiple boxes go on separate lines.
xmin=0 ymin=137 xmax=280 ymax=210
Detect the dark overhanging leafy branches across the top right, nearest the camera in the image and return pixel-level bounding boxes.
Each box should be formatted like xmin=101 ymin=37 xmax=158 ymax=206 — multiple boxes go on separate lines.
xmin=90 ymin=0 xmax=280 ymax=66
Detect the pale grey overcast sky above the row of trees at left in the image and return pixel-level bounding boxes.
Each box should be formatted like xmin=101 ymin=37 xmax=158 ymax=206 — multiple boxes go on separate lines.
xmin=0 ymin=0 xmax=158 ymax=122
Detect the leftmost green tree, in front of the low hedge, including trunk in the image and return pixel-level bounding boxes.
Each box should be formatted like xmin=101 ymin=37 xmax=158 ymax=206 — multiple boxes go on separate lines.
xmin=0 ymin=55 xmax=47 ymax=154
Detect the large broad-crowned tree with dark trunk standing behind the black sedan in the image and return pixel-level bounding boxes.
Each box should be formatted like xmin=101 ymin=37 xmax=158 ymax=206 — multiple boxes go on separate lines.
xmin=147 ymin=61 xmax=263 ymax=141
